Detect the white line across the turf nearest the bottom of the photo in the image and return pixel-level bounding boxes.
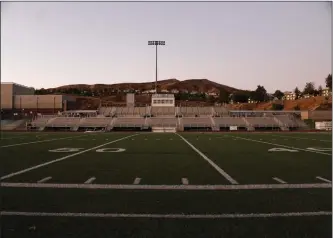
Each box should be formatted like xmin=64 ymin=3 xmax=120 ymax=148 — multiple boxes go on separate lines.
xmin=0 ymin=211 xmax=332 ymax=219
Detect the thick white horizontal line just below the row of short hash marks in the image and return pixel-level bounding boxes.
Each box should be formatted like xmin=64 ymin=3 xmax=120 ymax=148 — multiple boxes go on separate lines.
xmin=0 ymin=182 xmax=332 ymax=190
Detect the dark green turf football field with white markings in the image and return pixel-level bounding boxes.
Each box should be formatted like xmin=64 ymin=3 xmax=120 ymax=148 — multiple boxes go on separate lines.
xmin=0 ymin=132 xmax=332 ymax=238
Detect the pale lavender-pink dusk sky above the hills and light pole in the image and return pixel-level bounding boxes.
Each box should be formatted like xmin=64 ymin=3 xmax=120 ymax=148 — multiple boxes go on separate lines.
xmin=1 ymin=2 xmax=332 ymax=92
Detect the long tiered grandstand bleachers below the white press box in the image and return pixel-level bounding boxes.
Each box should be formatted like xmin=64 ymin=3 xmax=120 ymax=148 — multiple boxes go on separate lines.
xmin=31 ymin=106 xmax=307 ymax=131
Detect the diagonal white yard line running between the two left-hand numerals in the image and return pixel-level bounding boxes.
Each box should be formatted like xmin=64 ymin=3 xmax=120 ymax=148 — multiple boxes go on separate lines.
xmin=0 ymin=134 xmax=139 ymax=180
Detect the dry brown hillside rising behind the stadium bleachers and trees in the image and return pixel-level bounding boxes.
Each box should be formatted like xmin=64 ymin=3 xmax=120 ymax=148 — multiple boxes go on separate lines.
xmin=39 ymin=79 xmax=332 ymax=110
